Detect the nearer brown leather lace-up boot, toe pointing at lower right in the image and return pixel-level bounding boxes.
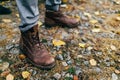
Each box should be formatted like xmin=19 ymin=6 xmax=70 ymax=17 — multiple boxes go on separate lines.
xmin=20 ymin=25 xmax=55 ymax=69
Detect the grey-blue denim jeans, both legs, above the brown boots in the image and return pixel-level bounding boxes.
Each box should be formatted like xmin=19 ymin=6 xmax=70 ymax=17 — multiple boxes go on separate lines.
xmin=16 ymin=0 xmax=61 ymax=32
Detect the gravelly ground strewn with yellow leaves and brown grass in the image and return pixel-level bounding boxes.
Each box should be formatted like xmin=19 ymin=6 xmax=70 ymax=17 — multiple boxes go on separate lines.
xmin=0 ymin=0 xmax=120 ymax=80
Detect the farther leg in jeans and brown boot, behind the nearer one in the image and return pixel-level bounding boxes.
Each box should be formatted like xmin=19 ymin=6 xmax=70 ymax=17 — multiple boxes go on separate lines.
xmin=45 ymin=0 xmax=79 ymax=28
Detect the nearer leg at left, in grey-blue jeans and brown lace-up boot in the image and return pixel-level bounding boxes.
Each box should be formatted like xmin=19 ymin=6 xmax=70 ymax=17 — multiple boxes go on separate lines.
xmin=16 ymin=0 xmax=55 ymax=69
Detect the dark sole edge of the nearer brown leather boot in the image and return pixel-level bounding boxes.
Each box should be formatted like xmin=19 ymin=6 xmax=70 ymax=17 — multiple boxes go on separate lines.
xmin=20 ymin=48 xmax=55 ymax=70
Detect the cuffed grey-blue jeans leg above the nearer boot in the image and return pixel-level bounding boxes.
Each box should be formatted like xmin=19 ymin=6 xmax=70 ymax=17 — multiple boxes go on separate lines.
xmin=16 ymin=0 xmax=39 ymax=32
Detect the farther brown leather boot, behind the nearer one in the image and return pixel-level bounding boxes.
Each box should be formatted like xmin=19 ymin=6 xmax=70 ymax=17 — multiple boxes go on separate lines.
xmin=45 ymin=11 xmax=79 ymax=28
